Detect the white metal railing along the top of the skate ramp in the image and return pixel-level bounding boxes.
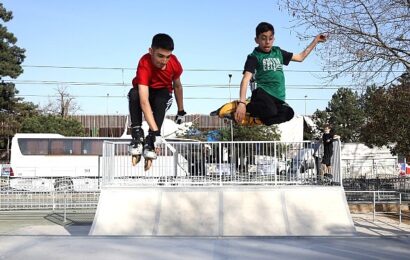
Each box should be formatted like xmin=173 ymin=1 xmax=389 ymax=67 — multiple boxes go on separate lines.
xmin=102 ymin=141 xmax=341 ymax=187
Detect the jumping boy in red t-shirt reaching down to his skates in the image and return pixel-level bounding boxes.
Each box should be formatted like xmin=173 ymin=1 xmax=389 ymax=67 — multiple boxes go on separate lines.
xmin=128 ymin=33 xmax=186 ymax=159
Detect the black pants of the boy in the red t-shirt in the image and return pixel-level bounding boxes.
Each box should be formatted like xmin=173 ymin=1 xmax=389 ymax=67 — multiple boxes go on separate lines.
xmin=128 ymin=87 xmax=172 ymax=130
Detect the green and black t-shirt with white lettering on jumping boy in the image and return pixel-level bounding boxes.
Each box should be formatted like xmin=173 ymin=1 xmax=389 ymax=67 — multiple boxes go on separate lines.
xmin=244 ymin=46 xmax=293 ymax=101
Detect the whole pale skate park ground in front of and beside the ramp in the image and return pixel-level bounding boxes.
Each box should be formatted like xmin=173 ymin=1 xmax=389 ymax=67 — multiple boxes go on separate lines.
xmin=0 ymin=211 xmax=410 ymax=260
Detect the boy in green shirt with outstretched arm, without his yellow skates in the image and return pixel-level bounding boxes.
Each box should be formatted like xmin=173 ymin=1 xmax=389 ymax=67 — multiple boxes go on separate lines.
xmin=234 ymin=22 xmax=327 ymax=125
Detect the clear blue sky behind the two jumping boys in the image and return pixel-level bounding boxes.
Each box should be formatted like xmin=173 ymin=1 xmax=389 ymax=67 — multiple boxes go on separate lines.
xmin=2 ymin=0 xmax=335 ymax=115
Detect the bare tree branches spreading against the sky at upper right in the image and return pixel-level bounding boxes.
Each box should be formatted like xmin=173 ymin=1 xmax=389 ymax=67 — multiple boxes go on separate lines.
xmin=277 ymin=0 xmax=410 ymax=85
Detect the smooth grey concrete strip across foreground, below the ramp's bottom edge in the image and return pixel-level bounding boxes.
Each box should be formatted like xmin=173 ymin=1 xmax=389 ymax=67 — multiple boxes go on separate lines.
xmin=0 ymin=236 xmax=410 ymax=260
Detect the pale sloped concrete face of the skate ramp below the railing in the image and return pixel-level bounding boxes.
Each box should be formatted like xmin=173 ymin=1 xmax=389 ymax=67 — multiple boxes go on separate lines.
xmin=90 ymin=186 xmax=355 ymax=236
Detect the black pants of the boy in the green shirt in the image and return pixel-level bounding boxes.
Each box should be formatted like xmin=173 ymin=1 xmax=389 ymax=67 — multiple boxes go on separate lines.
xmin=246 ymin=88 xmax=295 ymax=125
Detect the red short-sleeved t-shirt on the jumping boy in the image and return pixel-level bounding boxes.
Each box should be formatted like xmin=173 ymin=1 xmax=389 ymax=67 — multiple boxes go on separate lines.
xmin=132 ymin=53 xmax=182 ymax=93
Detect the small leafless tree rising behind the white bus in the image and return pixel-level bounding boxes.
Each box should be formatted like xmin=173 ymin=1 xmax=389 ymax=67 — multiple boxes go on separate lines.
xmin=42 ymin=85 xmax=81 ymax=118
